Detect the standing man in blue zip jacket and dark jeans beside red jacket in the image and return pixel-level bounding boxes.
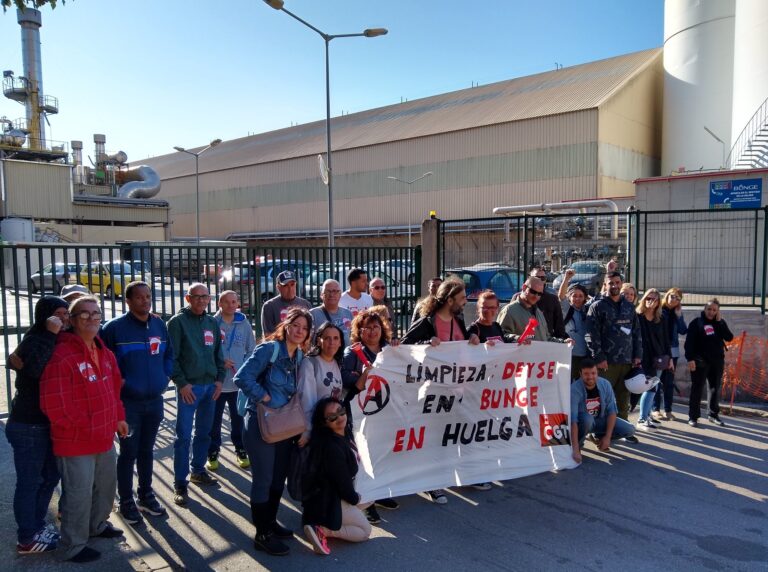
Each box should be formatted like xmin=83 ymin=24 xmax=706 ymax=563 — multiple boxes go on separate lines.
xmin=100 ymin=282 xmax=173 ymax=524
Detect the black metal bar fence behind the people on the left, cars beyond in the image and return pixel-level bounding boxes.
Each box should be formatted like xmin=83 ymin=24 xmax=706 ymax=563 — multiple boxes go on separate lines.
xmin=0 ymin=243 xmax=421 ymax=414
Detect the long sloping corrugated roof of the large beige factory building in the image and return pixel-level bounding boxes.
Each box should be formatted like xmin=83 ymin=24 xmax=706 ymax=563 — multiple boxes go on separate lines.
xmin=141 ymin=48 xmax=661 ymax=179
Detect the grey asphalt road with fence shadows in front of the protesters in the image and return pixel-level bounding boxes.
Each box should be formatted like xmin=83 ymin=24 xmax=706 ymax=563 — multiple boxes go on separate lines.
xmin=0 ymin=400 xmax=768 ymax=572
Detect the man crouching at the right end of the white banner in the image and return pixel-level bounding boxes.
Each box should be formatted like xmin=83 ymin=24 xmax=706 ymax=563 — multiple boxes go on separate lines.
xmin=571 ymin=358 xmax=635 ymax=463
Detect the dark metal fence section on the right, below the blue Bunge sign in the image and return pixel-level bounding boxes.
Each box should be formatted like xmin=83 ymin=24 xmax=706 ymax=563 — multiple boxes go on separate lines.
xmin=441 ymin=207 xmax=768 ymax=312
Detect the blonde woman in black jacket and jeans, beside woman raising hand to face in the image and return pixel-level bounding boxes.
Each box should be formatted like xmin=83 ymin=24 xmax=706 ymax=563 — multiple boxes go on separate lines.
xmin=635 ymin=288 xmax=671 ymax=431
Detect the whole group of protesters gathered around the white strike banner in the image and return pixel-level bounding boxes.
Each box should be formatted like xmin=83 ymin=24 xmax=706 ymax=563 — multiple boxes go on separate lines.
xmin=6 ymin=268 xmax=733 ymax=562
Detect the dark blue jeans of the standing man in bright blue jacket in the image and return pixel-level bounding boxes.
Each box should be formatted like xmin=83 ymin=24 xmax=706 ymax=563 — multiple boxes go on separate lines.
xmin=117 ymin=395 xmax=163 ymax=502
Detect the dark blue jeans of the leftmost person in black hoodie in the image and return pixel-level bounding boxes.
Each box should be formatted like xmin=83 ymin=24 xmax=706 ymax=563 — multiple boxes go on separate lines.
xmin=5 ymin=421 xmax=60 ymax=544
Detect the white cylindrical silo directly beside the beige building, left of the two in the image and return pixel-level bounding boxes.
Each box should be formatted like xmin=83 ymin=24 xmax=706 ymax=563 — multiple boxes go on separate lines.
xmin=661 ymin=0 xmax=735 ymax=175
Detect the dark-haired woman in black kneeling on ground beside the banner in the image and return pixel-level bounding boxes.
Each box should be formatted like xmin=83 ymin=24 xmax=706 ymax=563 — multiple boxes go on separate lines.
xmin=301 ymin=397 xmax=371 ymax=555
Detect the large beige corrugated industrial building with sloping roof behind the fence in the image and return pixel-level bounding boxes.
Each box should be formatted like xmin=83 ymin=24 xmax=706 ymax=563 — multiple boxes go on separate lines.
xmin=145 ymin=49 xmax=663 ymax=244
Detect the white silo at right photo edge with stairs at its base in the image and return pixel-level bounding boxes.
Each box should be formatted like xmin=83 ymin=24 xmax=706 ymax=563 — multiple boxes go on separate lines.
xmin=731 ymin=0 xmax=768 ymax=168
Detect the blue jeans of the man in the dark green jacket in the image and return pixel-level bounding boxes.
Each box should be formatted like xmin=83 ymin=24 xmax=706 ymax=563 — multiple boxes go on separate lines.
xmin=173 ymin=383 xmax=216 ymax=487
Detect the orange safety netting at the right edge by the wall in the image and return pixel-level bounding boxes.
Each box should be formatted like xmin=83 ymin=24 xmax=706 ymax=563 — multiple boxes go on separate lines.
xmin=722 ymin=332 xmax=768 ymax=407
